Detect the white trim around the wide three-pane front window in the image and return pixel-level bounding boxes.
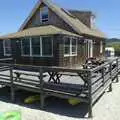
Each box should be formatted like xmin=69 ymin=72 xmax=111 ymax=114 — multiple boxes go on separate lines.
xmin=21 ymin=36 xmax=53 ymax=57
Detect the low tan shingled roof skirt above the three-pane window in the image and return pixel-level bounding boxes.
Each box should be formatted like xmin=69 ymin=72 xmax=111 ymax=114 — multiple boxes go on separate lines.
xmin=0 ymin=25 xmax=80 ymax=39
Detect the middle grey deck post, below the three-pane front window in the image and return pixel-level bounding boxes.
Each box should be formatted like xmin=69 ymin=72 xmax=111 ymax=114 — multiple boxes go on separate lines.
xmin=39 ymin=68 xmax=45 ymax=109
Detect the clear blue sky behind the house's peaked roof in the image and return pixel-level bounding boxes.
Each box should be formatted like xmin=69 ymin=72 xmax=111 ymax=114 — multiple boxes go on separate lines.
xmin=0 ymin=0 xmax=120 ymax=38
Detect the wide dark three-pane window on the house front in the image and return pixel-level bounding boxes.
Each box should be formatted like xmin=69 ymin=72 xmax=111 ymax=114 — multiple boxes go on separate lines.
xmin=21 ymin=37 xmax=53 ymax=57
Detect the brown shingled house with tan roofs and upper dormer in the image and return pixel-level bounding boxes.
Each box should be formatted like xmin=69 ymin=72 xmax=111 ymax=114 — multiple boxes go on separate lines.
xmin=0 ymin=0 xmax=106 ymax=67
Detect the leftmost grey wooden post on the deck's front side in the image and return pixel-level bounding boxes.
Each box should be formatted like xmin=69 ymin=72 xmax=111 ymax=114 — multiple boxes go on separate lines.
xmin=10 ymin=66 xmax=15 ymax=102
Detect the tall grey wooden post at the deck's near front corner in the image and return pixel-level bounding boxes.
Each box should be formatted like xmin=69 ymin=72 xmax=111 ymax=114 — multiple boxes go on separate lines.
xmin=87 ymin=71 xmax=93 ymax=118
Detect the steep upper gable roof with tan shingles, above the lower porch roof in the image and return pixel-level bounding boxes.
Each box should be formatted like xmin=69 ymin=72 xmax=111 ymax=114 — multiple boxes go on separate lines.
xmin=19 ymin=0 xmax=106 ymax=38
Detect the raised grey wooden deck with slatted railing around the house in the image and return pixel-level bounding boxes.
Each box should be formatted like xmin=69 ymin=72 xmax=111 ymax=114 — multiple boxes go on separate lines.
xmin=0 ymin=58 xmax=120 ymax=117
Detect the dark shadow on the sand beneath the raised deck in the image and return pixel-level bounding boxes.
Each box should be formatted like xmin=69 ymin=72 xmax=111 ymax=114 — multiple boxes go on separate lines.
xmin=0 ymin=87 xmax=88 ymax=118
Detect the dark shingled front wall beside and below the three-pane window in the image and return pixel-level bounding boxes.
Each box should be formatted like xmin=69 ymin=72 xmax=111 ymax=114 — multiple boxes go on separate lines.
xmin=12 ymin=35 xmax=61 ymax=66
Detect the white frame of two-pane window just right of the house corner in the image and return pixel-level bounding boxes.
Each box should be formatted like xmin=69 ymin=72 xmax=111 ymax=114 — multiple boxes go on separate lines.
xmin=64 ymin=37 xmax=78 ymax=57
